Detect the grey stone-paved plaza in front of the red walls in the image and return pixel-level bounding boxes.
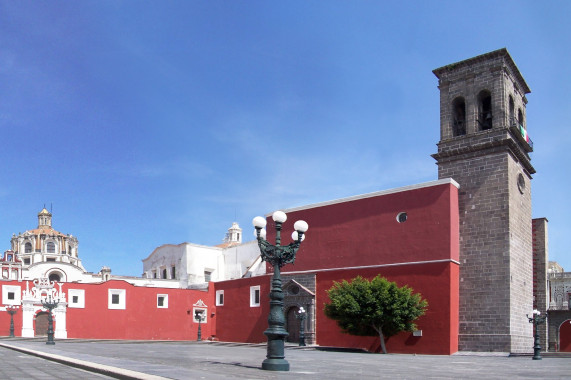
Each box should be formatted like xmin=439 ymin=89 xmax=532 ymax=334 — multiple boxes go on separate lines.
xmin=0 ymin=338 xmax=571 ymax=380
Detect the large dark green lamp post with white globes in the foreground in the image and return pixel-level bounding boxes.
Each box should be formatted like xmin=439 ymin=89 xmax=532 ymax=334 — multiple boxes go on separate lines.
xmin=252 ymin=211 xmax=308 ymax=371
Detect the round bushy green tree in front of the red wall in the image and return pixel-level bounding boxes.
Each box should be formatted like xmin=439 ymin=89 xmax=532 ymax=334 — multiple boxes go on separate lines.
xmin=325 ymin=276 xmax=428 ymax=354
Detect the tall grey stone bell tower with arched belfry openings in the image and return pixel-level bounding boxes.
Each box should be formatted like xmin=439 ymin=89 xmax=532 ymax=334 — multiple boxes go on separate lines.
xmin=432 ymin=49 xmax=535 ymax=352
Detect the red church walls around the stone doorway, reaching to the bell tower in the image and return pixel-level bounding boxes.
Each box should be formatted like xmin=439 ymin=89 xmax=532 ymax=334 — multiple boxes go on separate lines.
xmin=215 ymin=183 xmax=459 ymax=354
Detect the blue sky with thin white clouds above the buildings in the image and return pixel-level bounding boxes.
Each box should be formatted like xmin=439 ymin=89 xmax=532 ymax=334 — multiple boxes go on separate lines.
xmin=0 ymin=0 xmax=571 ymax=275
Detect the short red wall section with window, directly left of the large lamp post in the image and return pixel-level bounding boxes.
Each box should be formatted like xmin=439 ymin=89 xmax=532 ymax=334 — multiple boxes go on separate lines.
xmin=211 ymin=276 xmax=271 ymax=343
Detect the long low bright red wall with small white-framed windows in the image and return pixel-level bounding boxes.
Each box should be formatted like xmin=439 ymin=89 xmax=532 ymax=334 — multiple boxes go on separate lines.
xmin=63 ymin=280 xmax=215 ymax=340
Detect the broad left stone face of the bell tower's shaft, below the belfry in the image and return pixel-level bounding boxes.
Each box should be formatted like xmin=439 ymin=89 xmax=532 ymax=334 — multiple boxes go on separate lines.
xmin=438 ymin=147 xmax=510 ymax=352
